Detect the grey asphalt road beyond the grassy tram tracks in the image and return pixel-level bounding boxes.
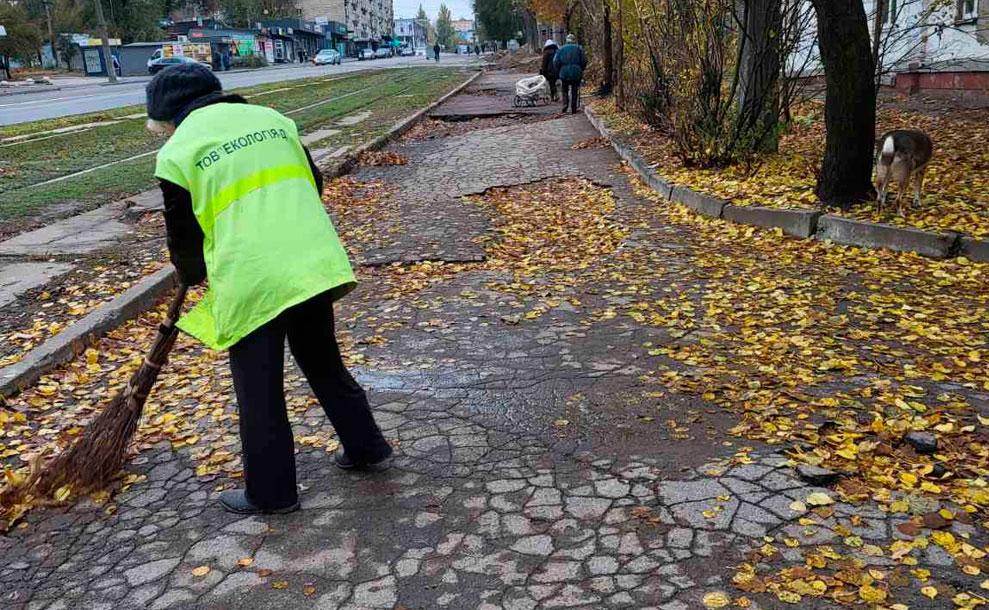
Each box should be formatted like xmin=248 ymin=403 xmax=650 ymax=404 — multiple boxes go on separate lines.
xmin=0 ymin=55 xmax=477 ymax=125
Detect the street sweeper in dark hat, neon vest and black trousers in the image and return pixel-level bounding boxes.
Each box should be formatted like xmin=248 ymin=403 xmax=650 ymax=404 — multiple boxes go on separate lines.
xmin=147 ymin=64 xmax=392 ymax=514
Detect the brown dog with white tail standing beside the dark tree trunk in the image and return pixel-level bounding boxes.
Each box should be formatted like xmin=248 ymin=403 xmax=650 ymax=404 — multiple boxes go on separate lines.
xmin=876 ymin=129 xmax=934 ymax=216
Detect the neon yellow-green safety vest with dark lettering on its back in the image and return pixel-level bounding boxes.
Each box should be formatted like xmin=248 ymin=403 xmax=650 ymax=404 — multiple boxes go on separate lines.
xmin=155 ymin=104 xmax=357 ymax=349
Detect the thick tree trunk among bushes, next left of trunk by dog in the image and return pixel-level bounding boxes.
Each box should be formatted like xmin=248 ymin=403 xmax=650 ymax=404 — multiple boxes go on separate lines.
xmin=738 ymin=0 xmax=783 ymax=152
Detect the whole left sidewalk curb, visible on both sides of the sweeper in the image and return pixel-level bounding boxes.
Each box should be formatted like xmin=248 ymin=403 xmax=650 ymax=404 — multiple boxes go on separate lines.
xmin=0 ymin=72 xmax=482 ymax=397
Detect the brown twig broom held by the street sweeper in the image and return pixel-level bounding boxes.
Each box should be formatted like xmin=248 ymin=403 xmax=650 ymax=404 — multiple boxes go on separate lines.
xmin=0 ymin=284 xmax=187 ymax=506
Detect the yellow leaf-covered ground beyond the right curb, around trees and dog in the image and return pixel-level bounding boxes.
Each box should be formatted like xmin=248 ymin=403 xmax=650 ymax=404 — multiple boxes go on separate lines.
xmin=590 ymin=99 xmax=989 ymax=237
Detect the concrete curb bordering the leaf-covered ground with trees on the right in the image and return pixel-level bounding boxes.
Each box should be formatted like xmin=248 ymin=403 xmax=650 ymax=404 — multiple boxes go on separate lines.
xmin=584 ymin=106 xmax=976 ymax=262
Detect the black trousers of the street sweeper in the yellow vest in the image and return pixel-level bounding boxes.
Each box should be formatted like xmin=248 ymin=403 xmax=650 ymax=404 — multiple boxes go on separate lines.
xmin=230 ymin=293 xmax=391 ymax=508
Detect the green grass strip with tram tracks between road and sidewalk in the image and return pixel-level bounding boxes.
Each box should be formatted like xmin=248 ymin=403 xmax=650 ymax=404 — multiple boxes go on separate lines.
xmin=0 ymin=68 xmax=468 ymax=227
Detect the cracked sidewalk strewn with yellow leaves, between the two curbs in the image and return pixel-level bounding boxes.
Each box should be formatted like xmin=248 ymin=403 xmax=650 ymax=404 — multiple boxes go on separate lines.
xmin=0 ymin=74 xmax=989 ymax=610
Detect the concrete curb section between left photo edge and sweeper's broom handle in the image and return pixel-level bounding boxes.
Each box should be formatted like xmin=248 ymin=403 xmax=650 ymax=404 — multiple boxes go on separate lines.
xmin=0 ymin=265 xmax=176 ymax=397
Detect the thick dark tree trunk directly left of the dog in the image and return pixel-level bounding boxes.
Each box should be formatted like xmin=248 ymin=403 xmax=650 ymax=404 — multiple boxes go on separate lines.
xmin=811 ymin=0 xmax=876 ymax=207
